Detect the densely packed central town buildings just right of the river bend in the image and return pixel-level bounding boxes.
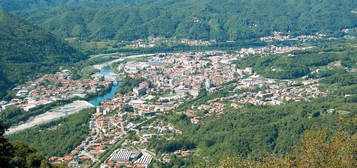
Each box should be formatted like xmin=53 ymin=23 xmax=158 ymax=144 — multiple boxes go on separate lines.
xmin=119 ymin=51 xmax=236 ymax=96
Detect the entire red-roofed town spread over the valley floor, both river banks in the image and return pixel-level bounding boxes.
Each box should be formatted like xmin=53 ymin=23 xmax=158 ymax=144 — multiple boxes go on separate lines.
xmin=3 ymin=42 xmax=326 ymax=168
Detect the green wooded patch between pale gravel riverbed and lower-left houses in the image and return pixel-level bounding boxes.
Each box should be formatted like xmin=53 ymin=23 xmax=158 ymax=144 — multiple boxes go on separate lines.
xmin=7 ymin=109 xmax=94 ymax=157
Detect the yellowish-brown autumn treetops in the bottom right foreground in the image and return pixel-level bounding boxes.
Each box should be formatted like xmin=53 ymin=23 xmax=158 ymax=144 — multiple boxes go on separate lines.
xmin=211 ymin=116 xmax=357 ymax=168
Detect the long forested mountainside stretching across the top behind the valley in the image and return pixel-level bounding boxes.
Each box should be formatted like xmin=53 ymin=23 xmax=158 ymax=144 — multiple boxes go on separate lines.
xmin=4 ymin=0 xmax=357 ymax=41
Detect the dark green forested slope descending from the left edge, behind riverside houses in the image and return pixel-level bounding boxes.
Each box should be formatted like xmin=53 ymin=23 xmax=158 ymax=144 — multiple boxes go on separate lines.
xmin=0 ymin=10 xmax=84 ymax=96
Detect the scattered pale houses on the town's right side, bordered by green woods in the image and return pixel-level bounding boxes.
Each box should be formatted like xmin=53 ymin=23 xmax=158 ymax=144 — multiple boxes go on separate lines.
xmin=192 ymin=75 xmax=326 ymax=115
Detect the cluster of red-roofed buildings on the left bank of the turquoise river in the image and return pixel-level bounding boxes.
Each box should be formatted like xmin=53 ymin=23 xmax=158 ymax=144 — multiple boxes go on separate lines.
xmin=2 ymin=70 xmax=112 ymax=111
